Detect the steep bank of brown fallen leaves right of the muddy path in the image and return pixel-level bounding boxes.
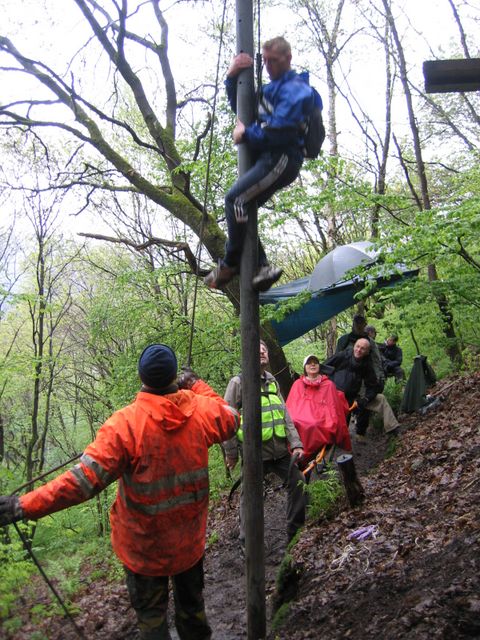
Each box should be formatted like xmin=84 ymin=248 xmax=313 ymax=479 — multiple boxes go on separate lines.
xmin=271 ymin=374 xmax=480 ymax=640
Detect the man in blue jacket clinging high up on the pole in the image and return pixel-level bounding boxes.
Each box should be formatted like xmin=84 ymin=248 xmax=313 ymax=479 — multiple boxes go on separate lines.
xmin=205 ymin=37 xmax=315 ymax=291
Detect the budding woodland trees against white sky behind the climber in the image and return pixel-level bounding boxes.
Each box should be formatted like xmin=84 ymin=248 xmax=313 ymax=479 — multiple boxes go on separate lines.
xmin=0 ymin=0 xmax=480 ymax=490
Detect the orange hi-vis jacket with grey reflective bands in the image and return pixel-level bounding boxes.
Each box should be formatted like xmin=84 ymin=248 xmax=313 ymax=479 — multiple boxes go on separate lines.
xmin=20 ymin=380 xmax=239 ymax=576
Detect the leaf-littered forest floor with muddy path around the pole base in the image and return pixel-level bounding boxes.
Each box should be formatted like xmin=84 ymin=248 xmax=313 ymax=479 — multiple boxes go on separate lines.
xmin=0 ymin=373 xmax=480 ymax=640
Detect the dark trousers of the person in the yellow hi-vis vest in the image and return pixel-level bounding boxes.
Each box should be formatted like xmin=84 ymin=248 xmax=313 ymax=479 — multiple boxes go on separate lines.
xmin=239 ymin=455 xmax=306 ymax=541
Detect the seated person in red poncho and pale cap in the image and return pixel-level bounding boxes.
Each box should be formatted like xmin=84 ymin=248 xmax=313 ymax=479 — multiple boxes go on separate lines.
xmin=286 ymin=355 xmax=352 ymax=461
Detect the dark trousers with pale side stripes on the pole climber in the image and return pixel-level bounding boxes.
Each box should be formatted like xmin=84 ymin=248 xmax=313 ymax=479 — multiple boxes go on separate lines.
xmin=224 ymin=152 xmax=303 ymax=267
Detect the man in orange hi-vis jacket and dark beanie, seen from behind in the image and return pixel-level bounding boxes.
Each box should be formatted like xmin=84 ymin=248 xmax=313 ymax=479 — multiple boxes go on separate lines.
xmin=0 ymin=344 xmax=239 ymax=640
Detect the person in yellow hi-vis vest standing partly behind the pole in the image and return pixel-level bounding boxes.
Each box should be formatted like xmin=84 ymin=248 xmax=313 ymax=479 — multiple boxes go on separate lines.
xmin=223 ymin=340 xmax=305 ymax=546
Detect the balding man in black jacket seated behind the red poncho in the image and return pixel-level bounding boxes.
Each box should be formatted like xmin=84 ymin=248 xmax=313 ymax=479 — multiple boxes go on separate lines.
xmin=325 ymin=338 xmax=381 ymax=441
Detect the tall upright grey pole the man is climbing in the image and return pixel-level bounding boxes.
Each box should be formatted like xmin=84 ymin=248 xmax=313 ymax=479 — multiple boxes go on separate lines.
xmin=236 ymin=0 xmax=266 ymax=640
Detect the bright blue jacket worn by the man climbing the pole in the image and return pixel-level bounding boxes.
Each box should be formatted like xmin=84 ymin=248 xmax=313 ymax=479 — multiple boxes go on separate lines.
xmin=225 ymin=70 xmax=315 ymax=153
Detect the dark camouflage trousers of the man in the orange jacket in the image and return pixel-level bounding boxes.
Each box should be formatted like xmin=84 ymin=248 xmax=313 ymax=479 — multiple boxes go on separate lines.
xmin=125 ymin=558 xmax=212 ymax=640
